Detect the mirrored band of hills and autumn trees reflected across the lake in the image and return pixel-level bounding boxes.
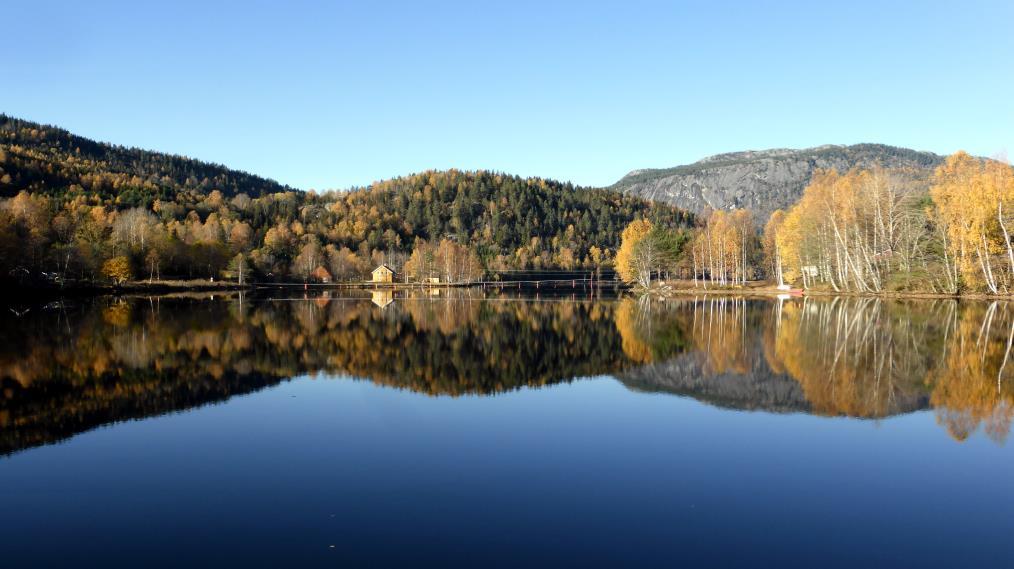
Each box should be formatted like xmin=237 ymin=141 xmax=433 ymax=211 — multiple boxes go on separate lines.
xmin=0 ymin=290 xmax=1014 ymax=453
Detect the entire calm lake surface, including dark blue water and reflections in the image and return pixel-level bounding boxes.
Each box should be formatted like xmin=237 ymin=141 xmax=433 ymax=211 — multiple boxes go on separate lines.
xmin=0 ymin=292 xmax=1014 ymax=567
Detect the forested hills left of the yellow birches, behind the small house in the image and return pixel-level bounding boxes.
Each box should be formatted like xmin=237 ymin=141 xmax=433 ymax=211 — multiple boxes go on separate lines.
xmin=0 ymin=117 xmax=693 ymax=283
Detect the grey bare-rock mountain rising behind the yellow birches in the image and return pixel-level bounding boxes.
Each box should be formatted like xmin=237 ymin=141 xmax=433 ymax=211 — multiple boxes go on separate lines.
xmin=609 ymin=144 xmax=943 ymax=223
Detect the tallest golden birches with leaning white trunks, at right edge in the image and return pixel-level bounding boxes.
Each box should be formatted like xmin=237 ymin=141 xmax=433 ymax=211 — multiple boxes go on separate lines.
xmin=766 ymin=152 xmax=1014 ymax=294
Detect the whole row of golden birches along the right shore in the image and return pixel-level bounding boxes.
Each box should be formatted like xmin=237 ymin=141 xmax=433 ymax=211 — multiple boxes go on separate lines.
xmin=618 ymin=152 xmax=1014 ymax=294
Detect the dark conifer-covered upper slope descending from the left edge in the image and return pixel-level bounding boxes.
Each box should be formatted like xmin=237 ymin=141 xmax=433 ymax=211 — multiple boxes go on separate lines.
xmin=0 ymin=115 xmax=291 ymax=206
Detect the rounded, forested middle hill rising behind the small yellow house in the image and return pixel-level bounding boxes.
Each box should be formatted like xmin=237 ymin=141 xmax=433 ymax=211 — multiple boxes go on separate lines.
xmin=338 ymin=169 xmax=691 ymax=267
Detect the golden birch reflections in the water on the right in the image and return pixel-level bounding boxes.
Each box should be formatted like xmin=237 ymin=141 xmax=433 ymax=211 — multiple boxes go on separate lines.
xmin=618 ymin=297 xmax=1014 ymax=442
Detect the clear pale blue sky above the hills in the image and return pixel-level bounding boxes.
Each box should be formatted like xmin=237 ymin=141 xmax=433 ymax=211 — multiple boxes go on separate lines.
xmin=0 ymin=0 xmax=1014 ymax=189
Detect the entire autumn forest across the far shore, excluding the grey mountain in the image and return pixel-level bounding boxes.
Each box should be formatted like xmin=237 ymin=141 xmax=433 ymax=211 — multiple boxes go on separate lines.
xmin=0 ymin=116 xmax=1014 ymax=295
